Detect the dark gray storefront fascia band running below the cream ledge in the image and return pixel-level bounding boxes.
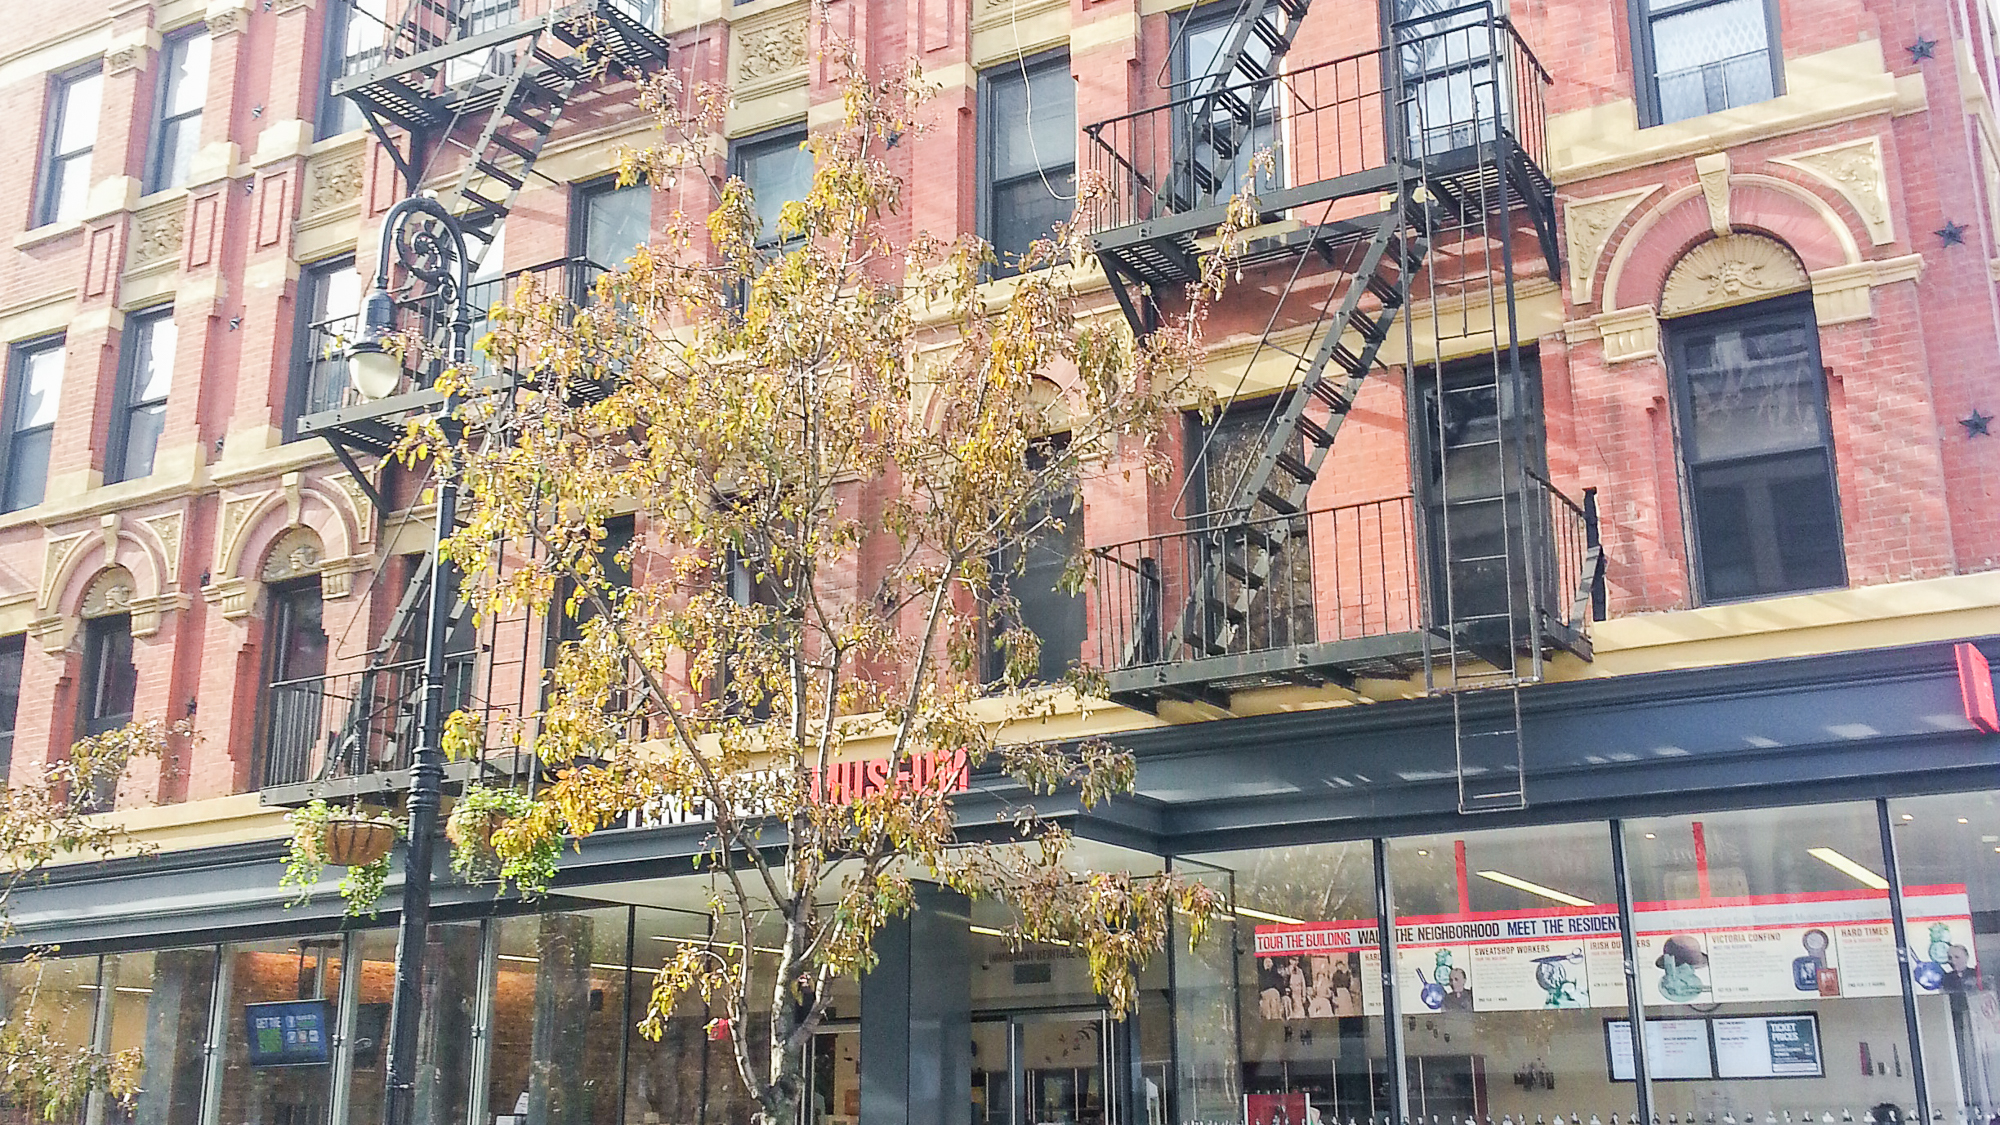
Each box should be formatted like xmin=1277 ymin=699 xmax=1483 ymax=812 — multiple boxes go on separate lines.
xmin=10 ymin=639 xmax=2000 ymax=1121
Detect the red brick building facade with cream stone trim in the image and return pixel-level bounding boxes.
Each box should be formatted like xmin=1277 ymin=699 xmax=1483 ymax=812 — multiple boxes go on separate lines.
xmin=0 ymin=0 xmax=2000 ymax=1125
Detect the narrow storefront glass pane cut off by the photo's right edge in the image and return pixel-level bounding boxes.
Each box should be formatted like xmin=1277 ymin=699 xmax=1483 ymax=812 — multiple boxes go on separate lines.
xmin=1888 ymin=793 xmax=2000 ymax=1121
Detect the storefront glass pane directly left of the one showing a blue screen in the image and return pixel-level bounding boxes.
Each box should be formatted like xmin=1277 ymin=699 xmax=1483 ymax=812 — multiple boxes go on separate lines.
xmin=102 ymin=945 xmax=216 ymax=1123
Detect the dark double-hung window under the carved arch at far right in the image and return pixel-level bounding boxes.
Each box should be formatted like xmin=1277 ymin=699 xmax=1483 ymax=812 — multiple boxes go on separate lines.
xmin=1668 ymin=294 xmax=1846 ymax=603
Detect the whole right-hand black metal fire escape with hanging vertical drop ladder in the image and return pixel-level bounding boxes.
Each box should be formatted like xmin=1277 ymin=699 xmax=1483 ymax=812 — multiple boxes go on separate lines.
xmin=1084 ymin=0 xmax=1602 ymax=809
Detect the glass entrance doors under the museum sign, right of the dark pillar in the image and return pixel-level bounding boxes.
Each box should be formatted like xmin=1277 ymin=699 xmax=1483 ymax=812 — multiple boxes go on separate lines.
xmin=972 ymin=1011 xmax=1120 ymax=1125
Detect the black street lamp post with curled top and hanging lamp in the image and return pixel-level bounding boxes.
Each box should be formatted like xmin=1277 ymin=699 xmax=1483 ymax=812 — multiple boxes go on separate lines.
xmin=348 ymin=196 xmax=472 ymax=1125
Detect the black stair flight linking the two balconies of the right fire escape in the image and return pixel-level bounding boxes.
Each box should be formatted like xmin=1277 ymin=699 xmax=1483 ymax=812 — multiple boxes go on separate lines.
xmin=1166 ymin=192 xmax=1428 ymax=657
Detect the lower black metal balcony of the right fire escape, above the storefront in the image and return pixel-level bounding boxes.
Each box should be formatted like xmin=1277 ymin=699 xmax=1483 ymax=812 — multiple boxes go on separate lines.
xmin=1090 ymin=480 xmax=1604 ymax=711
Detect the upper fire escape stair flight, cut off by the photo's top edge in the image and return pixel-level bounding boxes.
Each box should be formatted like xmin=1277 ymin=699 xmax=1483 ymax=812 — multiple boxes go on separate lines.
xmin=1168 ymin=0 xmax=1312 ymax=212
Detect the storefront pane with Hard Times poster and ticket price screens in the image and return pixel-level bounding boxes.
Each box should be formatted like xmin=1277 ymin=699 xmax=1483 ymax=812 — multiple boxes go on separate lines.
xmin=1606 ymin=803 xmax=1920 ymax=1121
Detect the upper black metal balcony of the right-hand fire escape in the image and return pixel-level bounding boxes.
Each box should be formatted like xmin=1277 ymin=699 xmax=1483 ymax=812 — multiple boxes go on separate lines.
xmin=1084 ymin=4 xmax=1556 ymax=284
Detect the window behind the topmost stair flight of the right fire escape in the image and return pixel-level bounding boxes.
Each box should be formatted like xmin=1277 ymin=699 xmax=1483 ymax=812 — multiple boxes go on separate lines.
xmin=1174 ymin=4 xmax=1284 ymax=210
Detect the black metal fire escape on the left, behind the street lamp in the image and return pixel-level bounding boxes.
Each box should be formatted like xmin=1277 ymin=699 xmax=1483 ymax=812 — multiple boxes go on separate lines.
xmin=264 ymin=0 xmax=668 ymax=805
